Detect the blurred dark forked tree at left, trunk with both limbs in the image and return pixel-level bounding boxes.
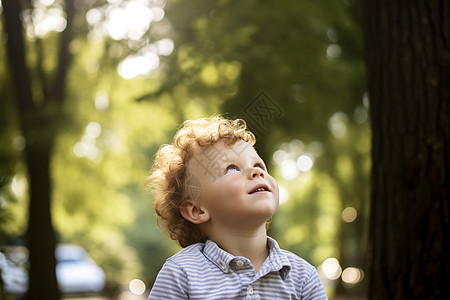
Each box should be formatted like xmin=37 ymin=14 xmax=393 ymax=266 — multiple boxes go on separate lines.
xmin=3 ymin=0 xmax=74 ymax=300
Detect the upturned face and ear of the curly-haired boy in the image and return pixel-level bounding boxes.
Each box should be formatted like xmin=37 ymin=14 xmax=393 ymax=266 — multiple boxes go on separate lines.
xmin=188 ymin=140 xmax=279 ymax=228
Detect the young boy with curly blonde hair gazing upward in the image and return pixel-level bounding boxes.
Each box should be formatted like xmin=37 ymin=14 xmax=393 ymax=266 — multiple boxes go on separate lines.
xmin=148 ymin=116 xmax=327 ymax=300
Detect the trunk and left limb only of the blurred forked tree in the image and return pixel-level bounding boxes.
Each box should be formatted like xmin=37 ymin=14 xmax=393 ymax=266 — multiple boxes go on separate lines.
xmin=3 ymin=0 xmax=60 ymax=300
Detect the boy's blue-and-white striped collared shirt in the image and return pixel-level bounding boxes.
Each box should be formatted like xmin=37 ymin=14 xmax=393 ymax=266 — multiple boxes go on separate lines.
xmin=148 ymin=237 xmax=327 ymax=300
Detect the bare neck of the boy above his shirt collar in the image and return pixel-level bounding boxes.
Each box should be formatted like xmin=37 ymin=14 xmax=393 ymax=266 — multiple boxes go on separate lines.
xmin=210 ymin=224 xmax=269 ymax=273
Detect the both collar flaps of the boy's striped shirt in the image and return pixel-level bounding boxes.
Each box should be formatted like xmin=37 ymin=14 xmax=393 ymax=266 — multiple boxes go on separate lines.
xmin=203 ymin=237 xmax=292 ymax=280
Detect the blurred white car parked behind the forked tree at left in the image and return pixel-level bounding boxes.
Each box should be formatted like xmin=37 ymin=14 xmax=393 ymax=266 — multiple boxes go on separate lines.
xmin=0 ymin=245 xmax=105 ymax=294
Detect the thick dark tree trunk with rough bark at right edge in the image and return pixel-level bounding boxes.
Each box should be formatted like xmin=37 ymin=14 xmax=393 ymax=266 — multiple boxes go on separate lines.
xmin=365 ymin=0 xmax=450 ymax=299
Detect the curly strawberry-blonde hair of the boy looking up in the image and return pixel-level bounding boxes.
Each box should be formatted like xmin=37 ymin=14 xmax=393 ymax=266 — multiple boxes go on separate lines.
xmin=147 ymin=116 xmax=256 ymax=247
